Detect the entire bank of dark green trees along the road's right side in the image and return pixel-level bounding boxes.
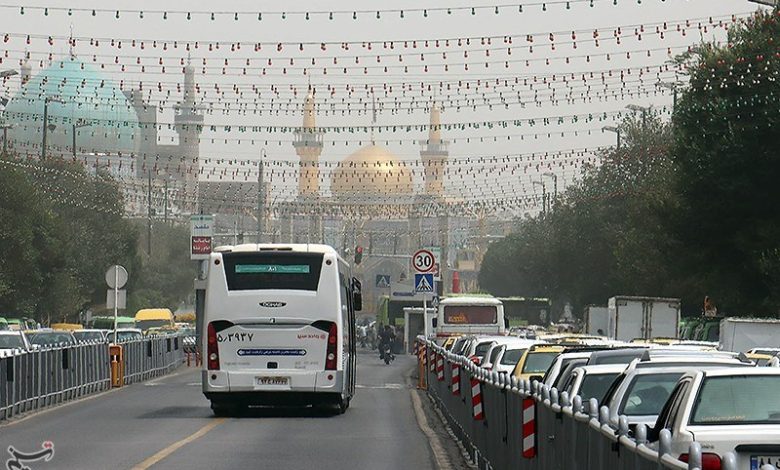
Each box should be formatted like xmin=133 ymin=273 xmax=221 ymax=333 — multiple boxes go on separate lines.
xmin=479 ymin=10 xmax=780 ymax=315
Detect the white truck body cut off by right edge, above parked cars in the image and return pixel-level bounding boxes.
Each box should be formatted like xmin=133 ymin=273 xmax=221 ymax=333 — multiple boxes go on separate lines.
xmin=718 ymin=317 xmax=780 ymax=352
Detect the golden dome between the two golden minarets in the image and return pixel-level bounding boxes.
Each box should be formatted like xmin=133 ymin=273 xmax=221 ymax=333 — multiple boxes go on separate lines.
xmin=330 ymin=144 xmax=414 ymax=197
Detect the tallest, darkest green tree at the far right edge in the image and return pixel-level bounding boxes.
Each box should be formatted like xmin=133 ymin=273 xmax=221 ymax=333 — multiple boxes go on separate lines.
xmin=672 ymin=11 xmax=780 ymax=314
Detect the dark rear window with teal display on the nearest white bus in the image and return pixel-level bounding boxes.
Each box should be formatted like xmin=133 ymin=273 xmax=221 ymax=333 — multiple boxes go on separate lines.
xmin=222 ymin=251 xmax=323 ymax=291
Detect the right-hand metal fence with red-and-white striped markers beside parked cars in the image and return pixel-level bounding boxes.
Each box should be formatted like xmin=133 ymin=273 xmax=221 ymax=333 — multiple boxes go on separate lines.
xmin=419 ymin=342 xmax=775 ymax=470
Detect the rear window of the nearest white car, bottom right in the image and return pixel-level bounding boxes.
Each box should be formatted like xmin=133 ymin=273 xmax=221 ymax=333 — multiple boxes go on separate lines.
xmin=690 ymin=375 xmax=780 ymax=425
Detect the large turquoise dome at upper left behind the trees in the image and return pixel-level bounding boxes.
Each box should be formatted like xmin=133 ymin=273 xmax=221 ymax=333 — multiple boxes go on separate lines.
xmin=3 ymin=56 xmax=139 ymax=155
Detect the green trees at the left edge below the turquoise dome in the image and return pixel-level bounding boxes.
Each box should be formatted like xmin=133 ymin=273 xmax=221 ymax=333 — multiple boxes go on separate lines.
xmin=0 ymin=157 xmax=136 ymax=321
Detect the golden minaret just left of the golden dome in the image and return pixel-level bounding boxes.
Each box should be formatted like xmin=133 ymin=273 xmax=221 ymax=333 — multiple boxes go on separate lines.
xmin=293 ymin=92 xmax=323 ymax=199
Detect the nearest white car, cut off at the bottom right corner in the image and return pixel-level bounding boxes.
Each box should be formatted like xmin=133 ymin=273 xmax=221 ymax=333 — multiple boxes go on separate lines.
xmin=648 ymin=367 xmax=780 ymax=470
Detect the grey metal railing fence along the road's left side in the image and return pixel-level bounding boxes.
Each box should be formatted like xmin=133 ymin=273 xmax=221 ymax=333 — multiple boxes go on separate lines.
xmin=0 ymin=336 xmax=183 ymax=421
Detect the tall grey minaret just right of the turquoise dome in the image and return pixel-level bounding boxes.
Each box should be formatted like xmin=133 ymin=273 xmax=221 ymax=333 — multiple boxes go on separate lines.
xmin=174 ymin=58 xmax=203 ymax=213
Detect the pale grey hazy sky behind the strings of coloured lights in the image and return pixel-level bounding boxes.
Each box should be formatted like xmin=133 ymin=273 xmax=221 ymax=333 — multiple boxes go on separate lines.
xmin=0 ymin=0 xmax=756 ymax=207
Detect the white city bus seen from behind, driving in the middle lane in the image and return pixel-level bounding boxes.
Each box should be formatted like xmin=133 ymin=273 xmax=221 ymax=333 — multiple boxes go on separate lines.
xmin=202 ymin=244 xmax=362 ymax=415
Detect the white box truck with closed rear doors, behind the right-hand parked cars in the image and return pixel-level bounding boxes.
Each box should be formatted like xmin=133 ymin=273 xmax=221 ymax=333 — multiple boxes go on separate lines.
xmin=607 ymin=295 xmax=680 ymax=341
